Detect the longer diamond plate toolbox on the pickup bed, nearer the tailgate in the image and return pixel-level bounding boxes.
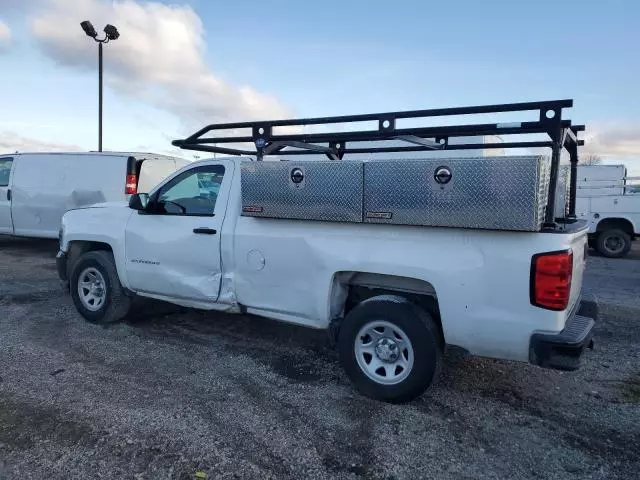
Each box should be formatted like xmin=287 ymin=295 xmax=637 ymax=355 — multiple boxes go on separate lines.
xmin=364 ymin=156 xmax=551 ymax=231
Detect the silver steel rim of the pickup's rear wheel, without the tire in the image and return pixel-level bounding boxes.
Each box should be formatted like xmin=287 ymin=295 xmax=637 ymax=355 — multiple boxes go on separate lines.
xmin=354 ymin=320 xmax=414 ymax=385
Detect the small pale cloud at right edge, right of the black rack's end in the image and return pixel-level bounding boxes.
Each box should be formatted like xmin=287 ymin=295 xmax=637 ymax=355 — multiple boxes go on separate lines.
xmin=580 ymin=124 xmax=640 ymax=157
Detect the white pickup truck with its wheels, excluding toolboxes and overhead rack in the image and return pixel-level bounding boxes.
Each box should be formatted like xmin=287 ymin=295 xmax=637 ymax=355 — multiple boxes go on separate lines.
xmin=57 ymin=102 xmax=596 ymax=402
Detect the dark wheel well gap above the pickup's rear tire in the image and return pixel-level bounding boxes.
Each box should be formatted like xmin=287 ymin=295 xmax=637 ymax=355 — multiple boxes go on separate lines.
xmin=331 ymin=272 xmax=445 ymax=345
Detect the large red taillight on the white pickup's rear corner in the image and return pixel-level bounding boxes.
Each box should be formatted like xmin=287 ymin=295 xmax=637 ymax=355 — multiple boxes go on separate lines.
xmin=530 ymin=250 xmax=573 ymax=310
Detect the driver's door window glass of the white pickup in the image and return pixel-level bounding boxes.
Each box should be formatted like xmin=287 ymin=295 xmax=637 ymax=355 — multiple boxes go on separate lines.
xmin=155 ymin=165 xmax=224 ymax=216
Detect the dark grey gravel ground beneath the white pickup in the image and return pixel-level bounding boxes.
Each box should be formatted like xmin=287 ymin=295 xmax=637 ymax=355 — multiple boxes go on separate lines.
xmin=0 ymin=238 xmax=640 ymax=480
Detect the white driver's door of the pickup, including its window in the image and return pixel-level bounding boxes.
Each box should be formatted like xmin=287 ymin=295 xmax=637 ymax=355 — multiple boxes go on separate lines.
xmin=125 ymin=160 xmax=234 ymax=302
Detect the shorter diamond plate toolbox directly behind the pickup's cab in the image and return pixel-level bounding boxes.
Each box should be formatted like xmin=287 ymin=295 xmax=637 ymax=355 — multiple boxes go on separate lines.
xmin=241 ymin=160 xmax=364 ymax=223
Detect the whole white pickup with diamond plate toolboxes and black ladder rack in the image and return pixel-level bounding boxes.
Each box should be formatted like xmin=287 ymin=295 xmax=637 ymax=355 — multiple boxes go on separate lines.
xmin=57 ymin=101 xmax=597 ymax=402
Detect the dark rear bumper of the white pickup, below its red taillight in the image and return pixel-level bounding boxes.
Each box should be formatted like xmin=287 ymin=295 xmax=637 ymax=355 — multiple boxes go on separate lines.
xmin=529 ymin=298 xmax=598 ymax=370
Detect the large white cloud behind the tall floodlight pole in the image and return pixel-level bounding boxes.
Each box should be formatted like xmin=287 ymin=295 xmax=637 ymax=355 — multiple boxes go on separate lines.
xmin=30 ymin=0 xmax=289 ymax=127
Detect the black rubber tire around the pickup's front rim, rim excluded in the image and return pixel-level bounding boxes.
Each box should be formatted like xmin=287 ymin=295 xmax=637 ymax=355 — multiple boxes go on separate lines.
xmin=70 ymin=251 xmax=131 ymax=324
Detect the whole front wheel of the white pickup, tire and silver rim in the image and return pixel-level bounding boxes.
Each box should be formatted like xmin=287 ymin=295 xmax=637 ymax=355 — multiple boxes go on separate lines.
xmin=70 ymin=251 xmax=131 ymax=324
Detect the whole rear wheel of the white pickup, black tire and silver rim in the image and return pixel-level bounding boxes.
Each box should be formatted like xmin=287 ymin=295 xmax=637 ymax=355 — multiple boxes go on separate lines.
xmin=338 ymin=295 xmax=442 ymax=403
